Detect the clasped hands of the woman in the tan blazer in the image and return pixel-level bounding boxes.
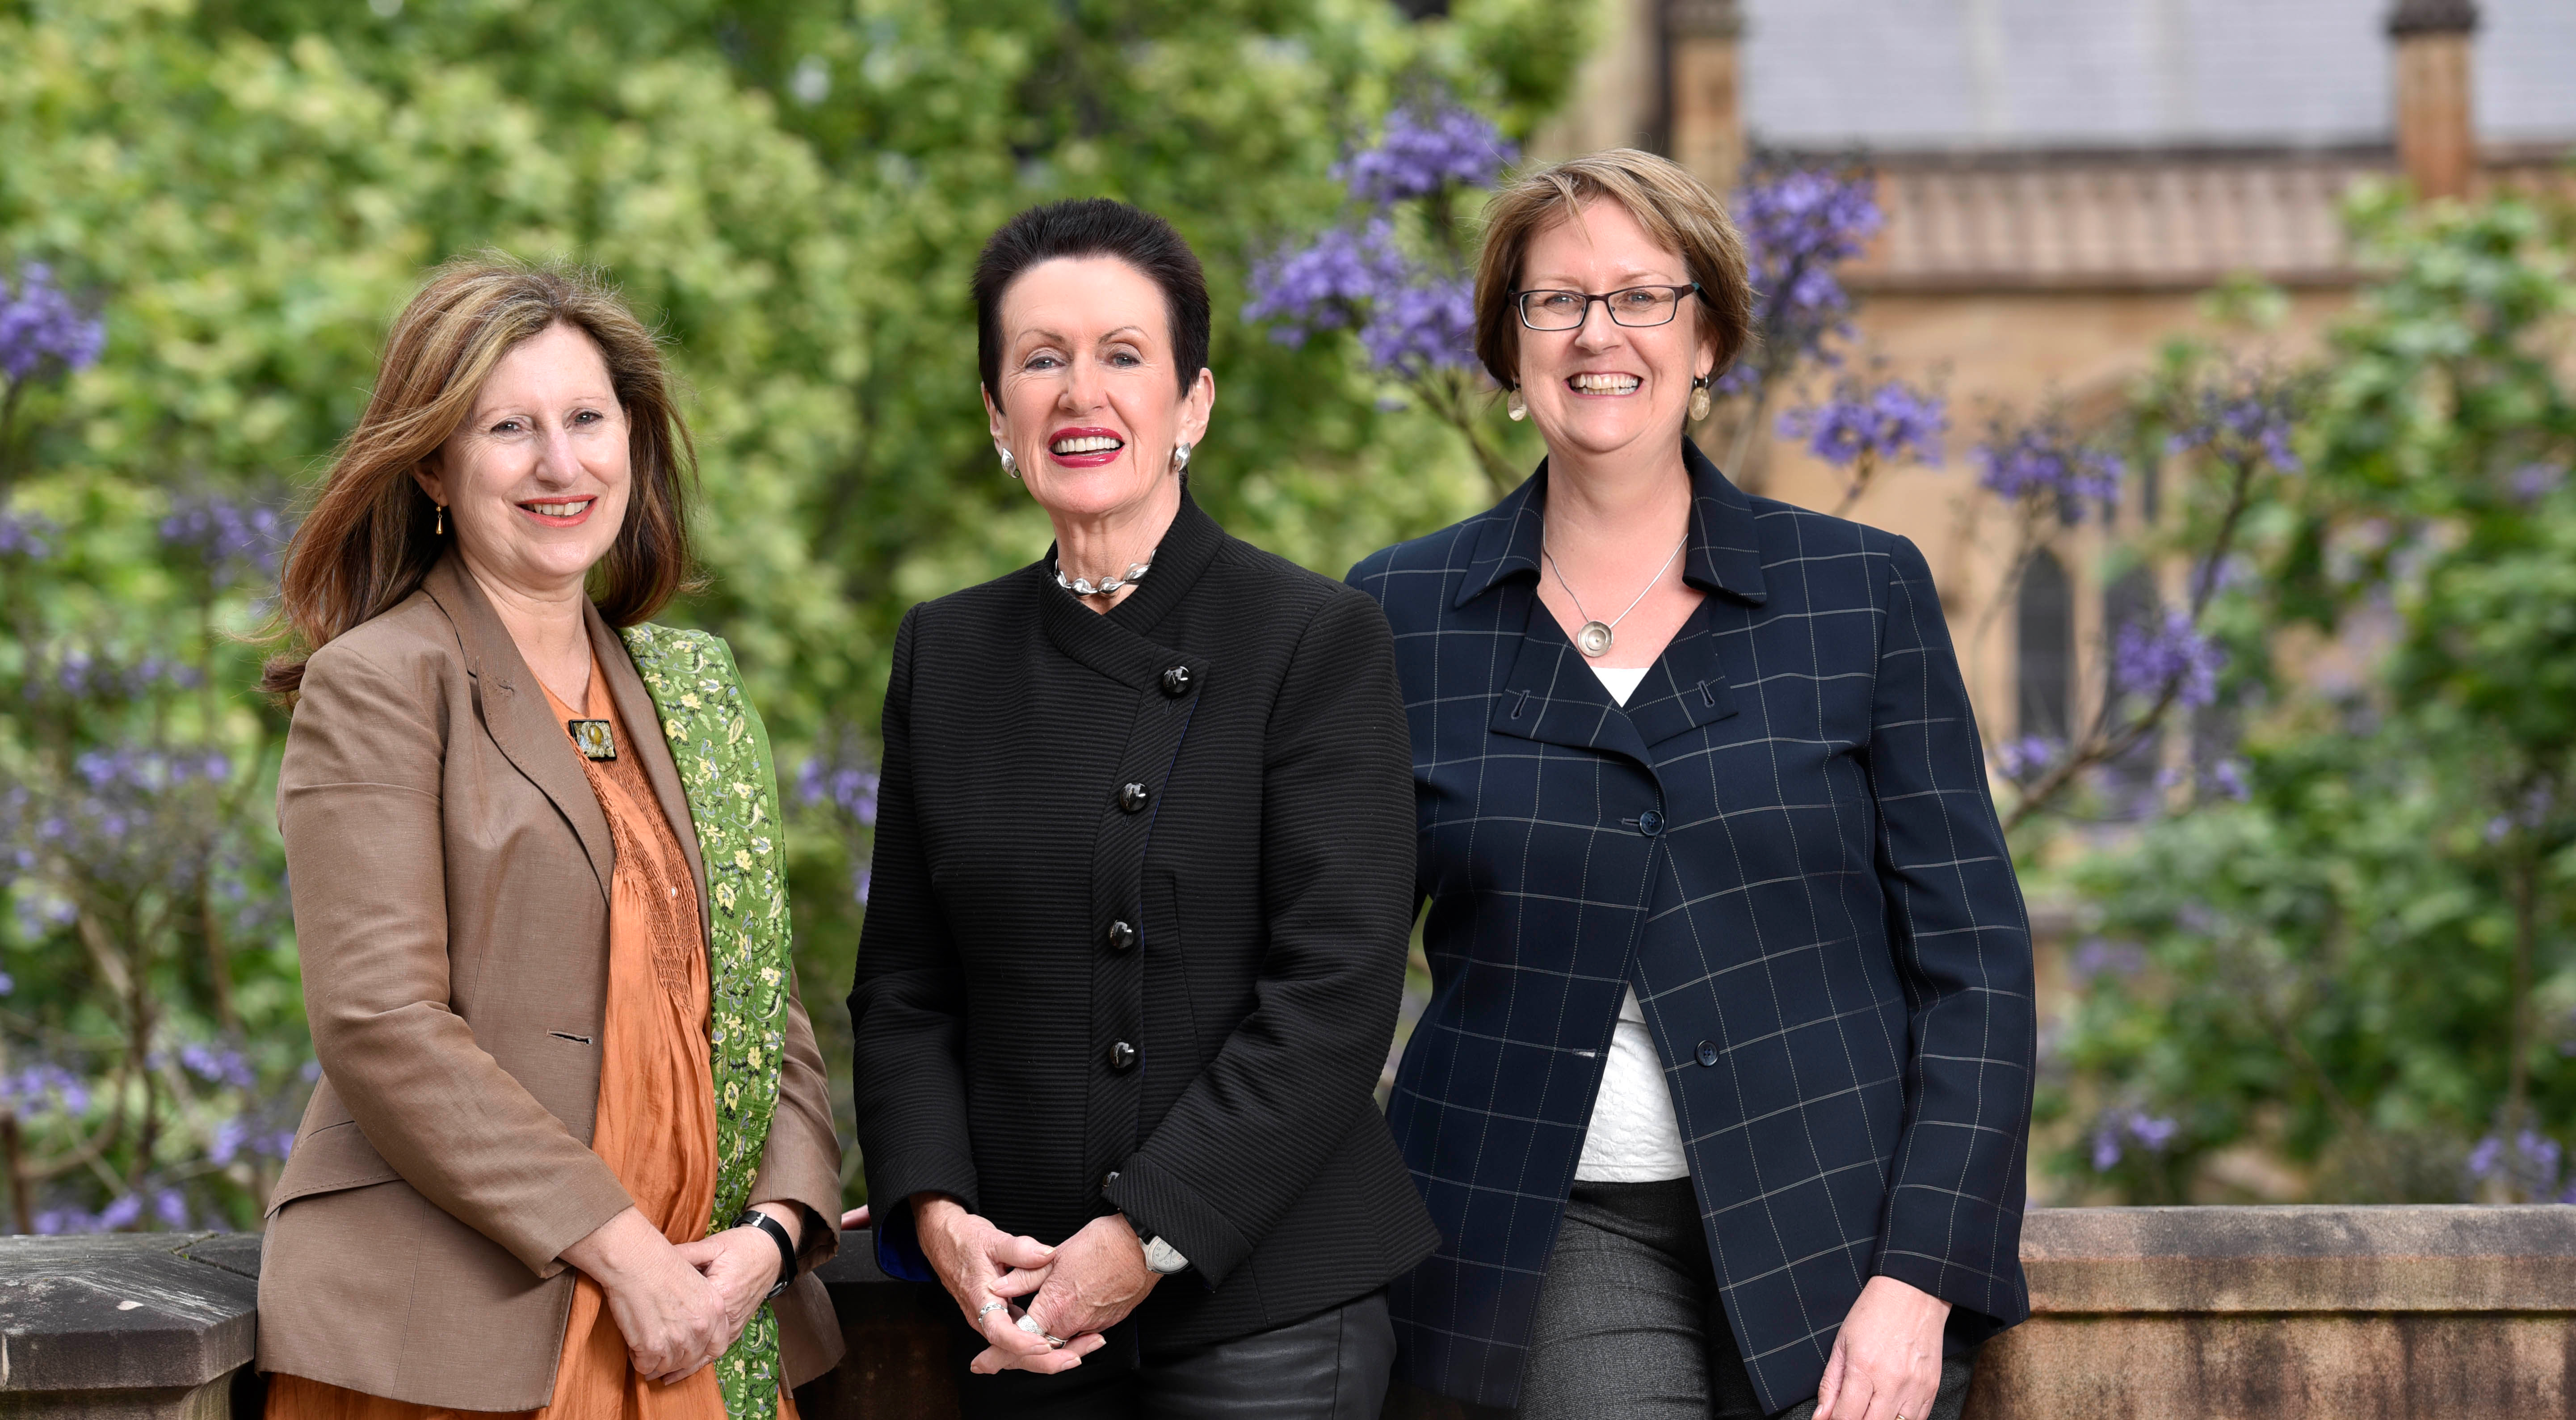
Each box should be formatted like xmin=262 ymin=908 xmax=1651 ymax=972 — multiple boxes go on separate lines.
xmin=564 ymin=1204 xmax=801 ymax=1386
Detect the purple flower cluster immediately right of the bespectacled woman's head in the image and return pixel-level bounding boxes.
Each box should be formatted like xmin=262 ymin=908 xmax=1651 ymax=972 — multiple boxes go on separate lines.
xmin=1718 ymin=165 xmax=1886 ymax=392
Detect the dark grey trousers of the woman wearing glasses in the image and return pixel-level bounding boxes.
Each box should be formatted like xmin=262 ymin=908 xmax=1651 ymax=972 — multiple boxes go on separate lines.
xmin=1515 ymin=1178 xmax=1968 ymax=1420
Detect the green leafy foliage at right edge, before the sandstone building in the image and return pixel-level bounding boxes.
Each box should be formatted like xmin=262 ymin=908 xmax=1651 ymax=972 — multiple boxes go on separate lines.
xmin=2048 ymin=193 xmax=2576 ymax=1201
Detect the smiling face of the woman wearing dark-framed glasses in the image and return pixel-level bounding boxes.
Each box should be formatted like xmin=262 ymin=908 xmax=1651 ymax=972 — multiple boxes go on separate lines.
xmin=1512 ymin=198 xmax=1715 ymax=456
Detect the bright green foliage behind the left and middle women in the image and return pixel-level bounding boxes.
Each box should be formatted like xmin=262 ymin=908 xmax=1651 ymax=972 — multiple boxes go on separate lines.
xmin=0 ymin=0 xmax=1589 ymax=1224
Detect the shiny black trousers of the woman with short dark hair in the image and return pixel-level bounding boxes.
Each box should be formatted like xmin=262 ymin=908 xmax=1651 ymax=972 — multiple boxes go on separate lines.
xmin=953 ymin=1283 xmax=1396 ymax=1420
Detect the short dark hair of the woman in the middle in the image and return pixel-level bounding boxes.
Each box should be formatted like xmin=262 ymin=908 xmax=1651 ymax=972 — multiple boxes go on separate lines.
xmin=974 ymin=198 xmax=1208 ymax=394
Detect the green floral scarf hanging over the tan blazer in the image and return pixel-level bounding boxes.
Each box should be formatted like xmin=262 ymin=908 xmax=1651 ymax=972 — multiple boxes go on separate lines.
xmin=621 ymin=624 xmax=794 ymax=1420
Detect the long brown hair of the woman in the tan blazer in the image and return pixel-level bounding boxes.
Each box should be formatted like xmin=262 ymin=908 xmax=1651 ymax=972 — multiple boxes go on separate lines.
xmin=260 ymin=253 xmax=698 ymax=699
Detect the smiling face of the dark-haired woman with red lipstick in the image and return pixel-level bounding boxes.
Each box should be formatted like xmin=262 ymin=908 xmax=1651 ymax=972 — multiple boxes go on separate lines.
xmin=984 ymin=258 xmax=1216 ymax=521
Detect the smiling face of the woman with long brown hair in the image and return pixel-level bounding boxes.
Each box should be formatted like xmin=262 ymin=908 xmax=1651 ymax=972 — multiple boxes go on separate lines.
xmin=417 ymin=325 xmax=634 ymax=598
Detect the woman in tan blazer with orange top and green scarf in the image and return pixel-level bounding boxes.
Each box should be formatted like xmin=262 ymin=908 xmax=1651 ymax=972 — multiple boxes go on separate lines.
xmin=260 ymin=260 xmax=840 ymax=1420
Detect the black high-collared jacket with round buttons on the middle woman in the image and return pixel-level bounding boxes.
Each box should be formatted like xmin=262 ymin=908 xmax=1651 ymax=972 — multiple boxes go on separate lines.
xmin=850 ymin=497 xmax=1440 ymax=1345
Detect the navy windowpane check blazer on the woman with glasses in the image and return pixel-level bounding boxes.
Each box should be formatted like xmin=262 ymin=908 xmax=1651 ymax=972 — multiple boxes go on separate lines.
xmin=1350 ymin=443 xmax=2033 ymax=1410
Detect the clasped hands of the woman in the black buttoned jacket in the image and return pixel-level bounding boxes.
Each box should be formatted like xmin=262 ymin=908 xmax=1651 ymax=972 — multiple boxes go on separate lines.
xmin=896 ymin=1193 xmax=1162 ymax=1376
